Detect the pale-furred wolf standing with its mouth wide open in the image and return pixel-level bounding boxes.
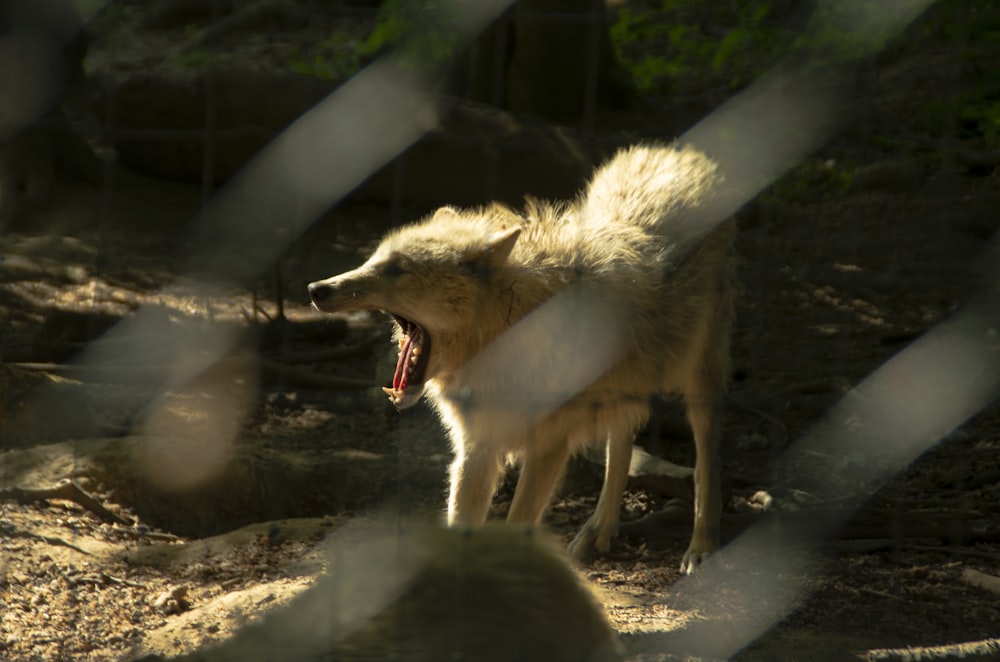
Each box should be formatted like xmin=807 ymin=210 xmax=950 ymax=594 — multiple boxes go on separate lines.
xmin=308 ymin=144 xmax=736 ymax=574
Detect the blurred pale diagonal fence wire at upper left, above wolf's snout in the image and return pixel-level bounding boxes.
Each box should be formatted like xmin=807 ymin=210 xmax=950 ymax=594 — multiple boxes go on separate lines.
xmin=79 ymin=1 xmax=507 ymax=404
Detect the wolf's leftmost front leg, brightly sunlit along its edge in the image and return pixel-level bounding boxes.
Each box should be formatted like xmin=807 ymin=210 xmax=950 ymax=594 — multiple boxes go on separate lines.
xmin=448 ymin=445 xmax=502 ymax=526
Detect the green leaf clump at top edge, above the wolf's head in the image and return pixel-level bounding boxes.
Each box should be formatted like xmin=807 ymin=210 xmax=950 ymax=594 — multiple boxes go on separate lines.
xmin=361 ymin=0 xmax=459 ymax=68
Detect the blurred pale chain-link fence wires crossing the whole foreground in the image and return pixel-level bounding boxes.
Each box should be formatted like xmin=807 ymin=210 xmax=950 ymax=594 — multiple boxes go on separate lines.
xmin=0 ymin=1 xmax=1000 ymax=660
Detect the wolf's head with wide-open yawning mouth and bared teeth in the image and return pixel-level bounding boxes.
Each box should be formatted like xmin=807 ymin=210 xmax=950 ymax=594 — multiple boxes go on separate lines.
xmin=309 ymin=207 xmax=521 ymax=409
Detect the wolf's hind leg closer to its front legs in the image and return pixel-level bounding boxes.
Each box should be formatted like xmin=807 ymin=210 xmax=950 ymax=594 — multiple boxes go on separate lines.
xmin=569 ymin=425 xmax=635 ymax=560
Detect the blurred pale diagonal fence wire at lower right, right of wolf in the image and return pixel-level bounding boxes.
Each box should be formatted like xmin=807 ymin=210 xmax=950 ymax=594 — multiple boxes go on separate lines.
xmin=671 ymin=268 xmax=1000 ymax=659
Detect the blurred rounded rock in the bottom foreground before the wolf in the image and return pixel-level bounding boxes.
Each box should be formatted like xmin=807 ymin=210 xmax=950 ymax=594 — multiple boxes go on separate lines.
xmin=164 ymin=524 xmax=621 ymax=662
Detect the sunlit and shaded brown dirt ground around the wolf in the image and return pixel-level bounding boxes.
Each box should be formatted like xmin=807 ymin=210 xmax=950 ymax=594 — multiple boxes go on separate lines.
xmin=0 ymin=1 xmax=1000 ymax=660
